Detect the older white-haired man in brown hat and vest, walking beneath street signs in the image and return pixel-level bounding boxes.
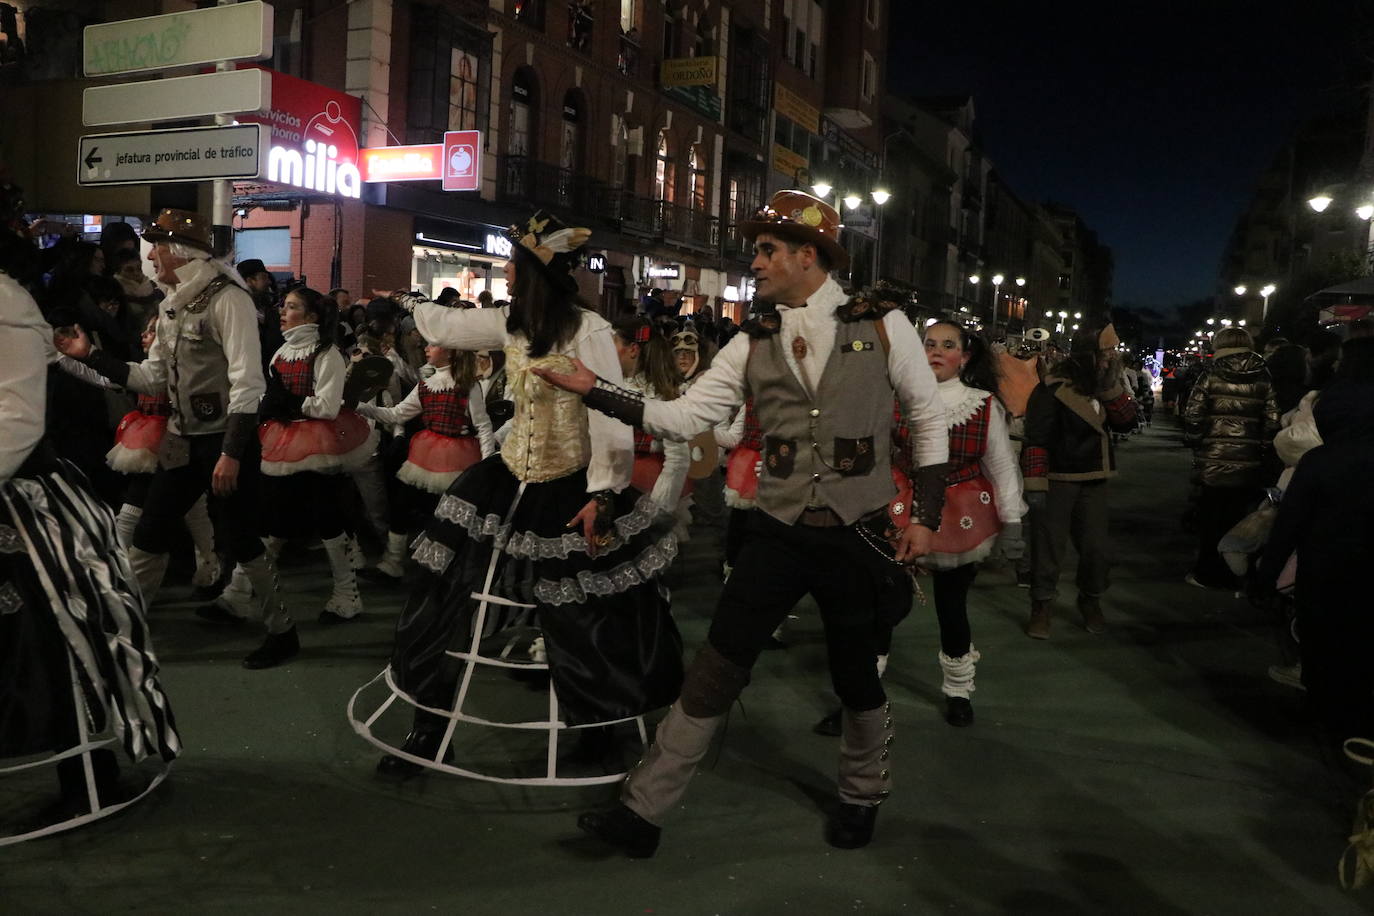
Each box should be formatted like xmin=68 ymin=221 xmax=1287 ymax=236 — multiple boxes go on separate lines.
xmin=56 ymin=210 xmax=300 ymax=667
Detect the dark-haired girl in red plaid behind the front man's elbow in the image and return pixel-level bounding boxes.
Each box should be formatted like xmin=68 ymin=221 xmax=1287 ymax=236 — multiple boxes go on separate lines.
xmin=892 ymin=321 xmax=1026 ymax=725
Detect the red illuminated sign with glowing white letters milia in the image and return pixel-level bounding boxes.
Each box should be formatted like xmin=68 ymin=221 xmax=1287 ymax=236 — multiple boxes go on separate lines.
xmin=239 ymin=70 xmax=363 ymax=199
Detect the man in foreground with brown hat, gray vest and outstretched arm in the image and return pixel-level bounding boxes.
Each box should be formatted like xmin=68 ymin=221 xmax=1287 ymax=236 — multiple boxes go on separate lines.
xmin=540 ymin=191 xmax=948 ymax=857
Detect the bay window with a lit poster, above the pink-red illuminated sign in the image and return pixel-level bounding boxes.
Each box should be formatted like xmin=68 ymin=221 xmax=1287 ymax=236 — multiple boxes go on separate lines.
xmin=405 ymin=5 xmax=492 ymax=143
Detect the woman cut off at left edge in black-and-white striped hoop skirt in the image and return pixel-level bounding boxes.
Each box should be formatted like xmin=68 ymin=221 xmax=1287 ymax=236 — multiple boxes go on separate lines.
xmin=0 ymin=201 xmax=180 ymax=846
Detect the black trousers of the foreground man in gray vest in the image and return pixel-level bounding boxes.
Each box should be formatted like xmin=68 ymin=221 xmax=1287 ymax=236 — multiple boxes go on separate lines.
xmin=706 ymin=511 xmax=900 ymax=711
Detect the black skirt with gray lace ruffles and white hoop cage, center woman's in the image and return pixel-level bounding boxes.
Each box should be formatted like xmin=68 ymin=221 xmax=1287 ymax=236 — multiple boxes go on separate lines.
xmin=348 ymin=455 xmax=683 ymax=786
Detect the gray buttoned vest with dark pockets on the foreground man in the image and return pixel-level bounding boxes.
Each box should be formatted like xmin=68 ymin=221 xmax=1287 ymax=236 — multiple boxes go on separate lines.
xmin=745 ymin=320 xmax=896 ymax=525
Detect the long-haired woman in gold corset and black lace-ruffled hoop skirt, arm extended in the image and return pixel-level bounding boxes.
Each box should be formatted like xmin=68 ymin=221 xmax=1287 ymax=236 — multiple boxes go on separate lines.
xmin=350 ymin=214 xmax=682 ymax=784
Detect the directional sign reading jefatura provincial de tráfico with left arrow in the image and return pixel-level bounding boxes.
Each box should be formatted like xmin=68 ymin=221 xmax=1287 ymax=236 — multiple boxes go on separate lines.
xmin=77 ymin=124 xmax=268 ymax=185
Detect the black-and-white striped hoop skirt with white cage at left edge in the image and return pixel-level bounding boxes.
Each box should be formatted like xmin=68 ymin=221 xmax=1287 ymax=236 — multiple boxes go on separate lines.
xmin=0 ymin=460 xmax=180 ymax=846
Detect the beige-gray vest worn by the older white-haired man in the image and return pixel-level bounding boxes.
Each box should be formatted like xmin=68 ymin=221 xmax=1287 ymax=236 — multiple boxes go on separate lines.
xmin=158 ymin=276 xmax=248 ymax=435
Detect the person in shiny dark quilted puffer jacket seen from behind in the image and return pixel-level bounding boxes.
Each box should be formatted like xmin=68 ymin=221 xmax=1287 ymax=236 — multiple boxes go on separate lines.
xmin=1183 ymin=327 xmax=1279 ymax=591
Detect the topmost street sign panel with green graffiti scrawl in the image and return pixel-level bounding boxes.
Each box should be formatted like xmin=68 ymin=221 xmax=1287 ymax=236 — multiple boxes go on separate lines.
xmin=81 ymin=0 xmax=272 ymax=77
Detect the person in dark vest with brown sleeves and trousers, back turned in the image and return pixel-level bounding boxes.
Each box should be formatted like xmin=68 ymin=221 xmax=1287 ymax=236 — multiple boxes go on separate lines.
xmin=1021 ymin=324 xmax=1135 ymax=639
